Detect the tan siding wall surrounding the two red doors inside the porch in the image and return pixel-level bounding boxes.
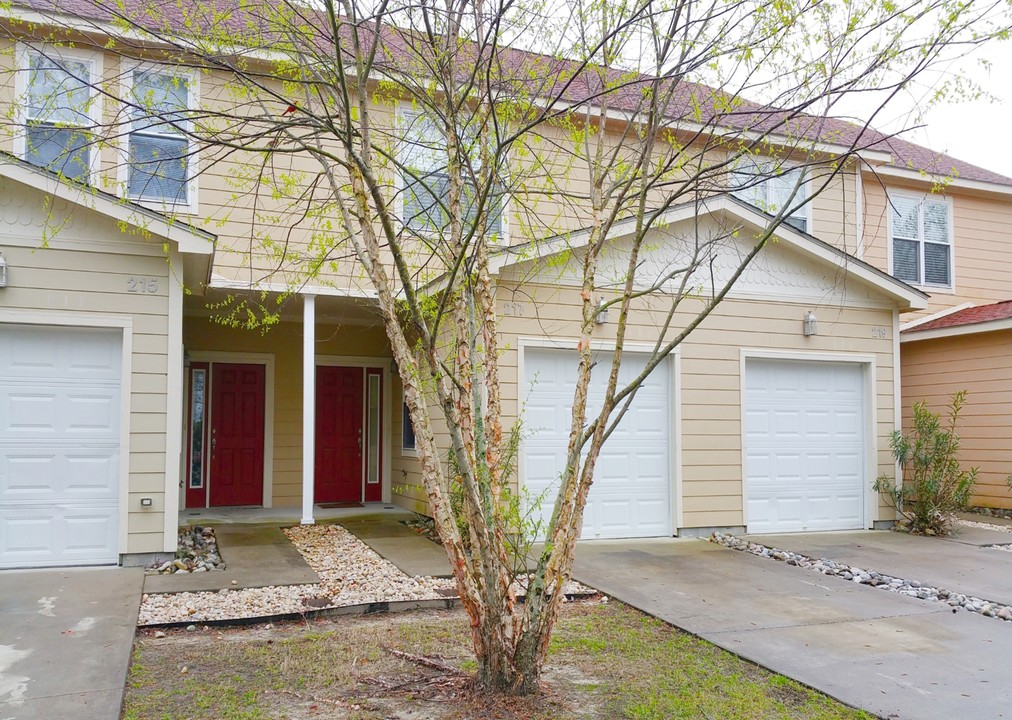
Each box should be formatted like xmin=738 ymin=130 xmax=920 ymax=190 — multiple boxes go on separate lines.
xmin=183 ymin=311 xmax=390 ymax=507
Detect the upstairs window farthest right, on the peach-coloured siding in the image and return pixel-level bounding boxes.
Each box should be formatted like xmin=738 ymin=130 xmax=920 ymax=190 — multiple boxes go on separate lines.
xmin=890 ymin=193 xmax=952 ymax=288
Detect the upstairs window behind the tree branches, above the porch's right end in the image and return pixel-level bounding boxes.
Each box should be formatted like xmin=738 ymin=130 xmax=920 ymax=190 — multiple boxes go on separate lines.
xmin=399 ymin=108 xmax=505 ymax=238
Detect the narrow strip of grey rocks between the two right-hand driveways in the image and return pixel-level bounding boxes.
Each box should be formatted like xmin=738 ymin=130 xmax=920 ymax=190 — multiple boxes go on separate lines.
xmin=709 ymin=533 xmax=1012 ymax=622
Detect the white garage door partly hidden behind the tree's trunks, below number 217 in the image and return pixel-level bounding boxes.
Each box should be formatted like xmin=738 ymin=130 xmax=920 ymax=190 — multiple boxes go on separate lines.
xmin=521 ymin=348 xmax=671 ymax=539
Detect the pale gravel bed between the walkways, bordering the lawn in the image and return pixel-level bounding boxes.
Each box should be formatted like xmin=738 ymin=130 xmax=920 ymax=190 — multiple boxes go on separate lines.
xmin=138 ymin=525 xmax=596 ymax=626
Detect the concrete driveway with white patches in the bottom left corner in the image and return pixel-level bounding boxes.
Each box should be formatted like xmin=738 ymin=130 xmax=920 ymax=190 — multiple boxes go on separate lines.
xmin=0 ymin=567 xmax=144 ymax=720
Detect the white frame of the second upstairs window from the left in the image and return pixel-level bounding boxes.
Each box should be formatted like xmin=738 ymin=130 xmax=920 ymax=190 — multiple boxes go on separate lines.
xmin=116 ymin=61 xmax=200 ymax=215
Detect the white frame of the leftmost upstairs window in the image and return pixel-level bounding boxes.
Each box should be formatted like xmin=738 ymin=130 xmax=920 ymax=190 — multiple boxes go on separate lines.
xmin=13 ymin=43 xmax=103 ymax=182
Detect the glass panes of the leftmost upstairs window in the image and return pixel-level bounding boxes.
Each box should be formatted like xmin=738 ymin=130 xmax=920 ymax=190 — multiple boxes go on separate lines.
xmin=24 ymin=50 xmax=97 ymax=182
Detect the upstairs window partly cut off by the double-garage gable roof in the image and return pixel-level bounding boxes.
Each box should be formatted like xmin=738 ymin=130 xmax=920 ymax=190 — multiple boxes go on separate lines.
xmin=731 ymin=157 xmax=811 ymax=233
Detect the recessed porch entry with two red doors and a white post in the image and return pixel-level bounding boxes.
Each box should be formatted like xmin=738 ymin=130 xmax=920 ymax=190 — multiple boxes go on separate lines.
xmin=180 ymin=288 xmax=392 ymax=524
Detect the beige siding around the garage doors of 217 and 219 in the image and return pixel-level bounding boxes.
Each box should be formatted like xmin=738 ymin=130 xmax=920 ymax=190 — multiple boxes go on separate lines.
xmin=500 ymin=286 xmax=894 ymax=528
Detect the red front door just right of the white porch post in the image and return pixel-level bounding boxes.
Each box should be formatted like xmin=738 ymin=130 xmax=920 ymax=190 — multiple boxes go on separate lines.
xmin=316 ymin=368 xmax=364 ymax=502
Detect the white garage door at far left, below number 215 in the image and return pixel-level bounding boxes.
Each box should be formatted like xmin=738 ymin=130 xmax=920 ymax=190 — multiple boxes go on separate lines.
xmin=0 ymin=325 xmax=122 ymax=567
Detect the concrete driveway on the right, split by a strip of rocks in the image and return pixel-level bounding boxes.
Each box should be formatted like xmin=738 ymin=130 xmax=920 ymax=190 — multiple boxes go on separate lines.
xmin=574 ymin=532 xmax=1012 ymax=720
